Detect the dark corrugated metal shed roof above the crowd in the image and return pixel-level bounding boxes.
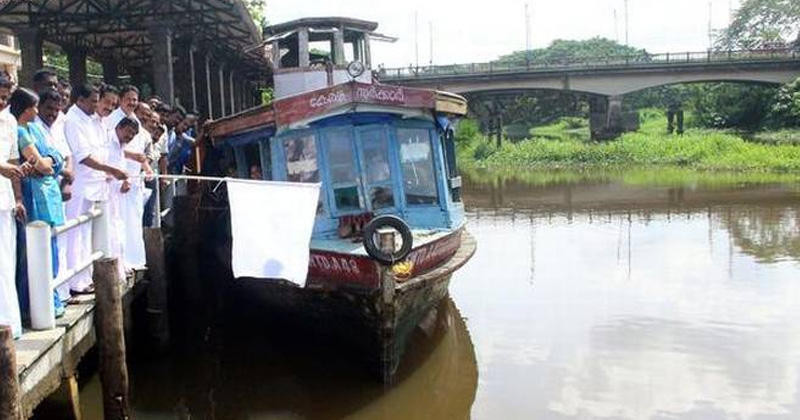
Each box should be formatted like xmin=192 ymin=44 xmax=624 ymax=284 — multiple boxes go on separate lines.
xmin=0 ymin=0 xmax=267 ymax=76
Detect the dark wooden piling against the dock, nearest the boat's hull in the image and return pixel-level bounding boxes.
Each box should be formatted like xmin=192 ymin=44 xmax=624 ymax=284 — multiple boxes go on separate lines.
xmin=144 ymin=228 xmax=170 ymax=350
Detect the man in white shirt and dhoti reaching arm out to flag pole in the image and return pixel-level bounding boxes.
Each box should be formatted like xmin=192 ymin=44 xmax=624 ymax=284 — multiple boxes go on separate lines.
xmin=64 ymin=84 xmax=128 ymax=293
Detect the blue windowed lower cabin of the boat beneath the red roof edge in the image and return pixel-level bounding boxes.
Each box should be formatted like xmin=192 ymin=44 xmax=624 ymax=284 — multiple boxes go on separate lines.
xmin=222 ymin=112 xmax=464 ymax=239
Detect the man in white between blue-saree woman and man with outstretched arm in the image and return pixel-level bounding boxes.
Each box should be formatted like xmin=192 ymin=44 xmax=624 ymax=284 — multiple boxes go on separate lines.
xmin=34 ymin=88 xmax=74 ymax=302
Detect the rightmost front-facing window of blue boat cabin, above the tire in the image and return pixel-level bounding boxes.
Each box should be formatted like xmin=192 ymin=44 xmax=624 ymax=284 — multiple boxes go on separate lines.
xmin=397 ymin=128 xmax=437 ymax=205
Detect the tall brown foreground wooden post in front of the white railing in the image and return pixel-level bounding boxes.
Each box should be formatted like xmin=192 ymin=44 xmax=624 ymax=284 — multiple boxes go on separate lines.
xmin=94 ymin=258 xmax=130 ymax=420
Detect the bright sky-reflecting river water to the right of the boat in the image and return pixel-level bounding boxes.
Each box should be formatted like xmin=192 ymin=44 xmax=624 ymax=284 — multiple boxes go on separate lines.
xmin=451 ymin=171 xmax=800 ymax=420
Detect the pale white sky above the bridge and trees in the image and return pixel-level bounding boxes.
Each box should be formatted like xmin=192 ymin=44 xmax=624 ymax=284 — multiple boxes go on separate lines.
xmin=266 ymin=0 xmax=740 ymax=68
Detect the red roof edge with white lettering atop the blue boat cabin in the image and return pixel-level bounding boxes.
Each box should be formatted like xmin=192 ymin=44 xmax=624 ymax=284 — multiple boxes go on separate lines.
xmin=206 ymin=82 xmax=467 ymax=146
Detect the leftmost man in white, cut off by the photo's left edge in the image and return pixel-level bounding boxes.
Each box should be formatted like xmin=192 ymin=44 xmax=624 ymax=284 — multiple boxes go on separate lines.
xmin=0 ymin=78 xmax=25 ymax=337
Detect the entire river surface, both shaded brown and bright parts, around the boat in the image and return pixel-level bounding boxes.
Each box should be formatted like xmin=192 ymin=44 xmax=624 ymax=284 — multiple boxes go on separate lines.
xmin=39 ymin=169 xmax=800 ymax=420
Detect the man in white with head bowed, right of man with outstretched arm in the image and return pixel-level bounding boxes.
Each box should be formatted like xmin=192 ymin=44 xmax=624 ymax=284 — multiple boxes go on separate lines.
xmin=107 ymin=117 xmax=139 ymax=281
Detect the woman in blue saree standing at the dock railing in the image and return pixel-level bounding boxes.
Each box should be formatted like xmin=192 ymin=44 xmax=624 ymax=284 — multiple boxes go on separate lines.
xmin=9 ymin=88 xmax=64 ymax=316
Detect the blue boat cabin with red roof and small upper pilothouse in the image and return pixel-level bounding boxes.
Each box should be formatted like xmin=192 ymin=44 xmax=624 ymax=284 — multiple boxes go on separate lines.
xmin=209 ymin=18 xmax=466 ymax=239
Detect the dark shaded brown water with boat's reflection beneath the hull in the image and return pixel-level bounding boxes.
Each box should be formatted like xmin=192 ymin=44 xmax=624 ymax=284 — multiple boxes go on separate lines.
xmin=76 ymin=298 xmax=478 ymax=420
